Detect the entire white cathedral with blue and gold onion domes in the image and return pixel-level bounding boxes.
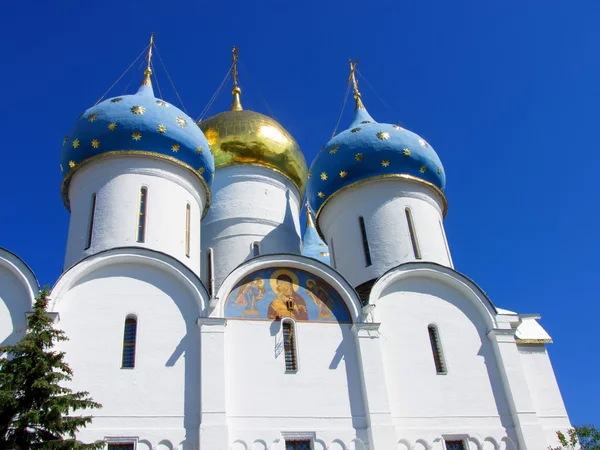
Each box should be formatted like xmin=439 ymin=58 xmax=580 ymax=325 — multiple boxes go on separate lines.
xmin=0 ymin=42 xmax=570 ymax=450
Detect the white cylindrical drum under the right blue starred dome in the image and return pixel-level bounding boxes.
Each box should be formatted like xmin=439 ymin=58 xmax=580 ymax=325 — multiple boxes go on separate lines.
xmin=318 ymin=179 xmax=452 ymax=286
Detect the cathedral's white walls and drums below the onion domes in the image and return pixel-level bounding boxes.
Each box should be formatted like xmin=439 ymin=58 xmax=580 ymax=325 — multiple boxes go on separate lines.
xmin=0 ymin=124 xmax=570 ymax=450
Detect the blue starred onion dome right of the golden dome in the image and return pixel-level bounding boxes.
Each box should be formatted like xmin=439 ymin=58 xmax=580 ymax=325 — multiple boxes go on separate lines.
xmin=307 ymin=61 xmax=446 ymax=218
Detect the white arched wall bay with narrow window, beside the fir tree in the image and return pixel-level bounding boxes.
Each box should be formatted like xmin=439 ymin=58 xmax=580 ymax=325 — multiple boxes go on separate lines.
xmin=53 ymin=255 xmax=207 ymax=449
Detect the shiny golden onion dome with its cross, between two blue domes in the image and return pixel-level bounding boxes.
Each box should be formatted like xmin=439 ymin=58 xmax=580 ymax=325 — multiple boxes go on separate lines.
xmin=198 ymin=47 xmax=307 ymax=194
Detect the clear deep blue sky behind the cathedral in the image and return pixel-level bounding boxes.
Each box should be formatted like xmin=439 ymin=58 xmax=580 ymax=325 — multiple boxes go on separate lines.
xmin=0 ymin=0 xmax=600 ymax=425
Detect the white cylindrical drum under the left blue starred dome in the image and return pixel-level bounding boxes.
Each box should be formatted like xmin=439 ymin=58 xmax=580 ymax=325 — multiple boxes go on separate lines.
xmin=65 ymin=156 xmax=206 ymax=274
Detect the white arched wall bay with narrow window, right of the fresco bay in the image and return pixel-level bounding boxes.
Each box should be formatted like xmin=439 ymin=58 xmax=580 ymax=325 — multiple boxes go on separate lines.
xmin=376 ymin=277 xmax=516 ymax=448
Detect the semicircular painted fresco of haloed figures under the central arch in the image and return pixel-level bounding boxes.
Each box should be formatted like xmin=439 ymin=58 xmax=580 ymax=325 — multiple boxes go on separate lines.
xmin=225 ymin=268 xmax=351 ymax=323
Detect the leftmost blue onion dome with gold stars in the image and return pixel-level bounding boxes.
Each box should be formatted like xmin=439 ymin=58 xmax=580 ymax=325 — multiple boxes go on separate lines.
xmin=60 ymin=68 xmax=214 ymax=214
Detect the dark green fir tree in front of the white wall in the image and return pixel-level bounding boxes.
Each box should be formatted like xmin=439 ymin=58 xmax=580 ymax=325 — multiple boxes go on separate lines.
xmin=0 ymin=289 xmax=104 ymax=450
